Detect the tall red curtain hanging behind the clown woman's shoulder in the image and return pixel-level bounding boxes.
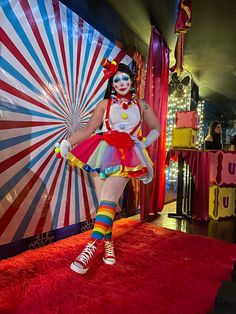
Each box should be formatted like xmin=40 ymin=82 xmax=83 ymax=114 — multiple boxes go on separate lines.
xmin=140 ymin=27 xmax=169 ymax=220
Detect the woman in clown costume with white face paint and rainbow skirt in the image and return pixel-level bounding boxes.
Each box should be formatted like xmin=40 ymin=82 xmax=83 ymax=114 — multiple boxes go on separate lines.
xmin=60 ymin=59 xmax=160 ymax=274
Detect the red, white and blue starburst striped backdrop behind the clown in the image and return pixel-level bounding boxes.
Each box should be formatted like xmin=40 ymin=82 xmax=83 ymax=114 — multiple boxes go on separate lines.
xmin=0 ymin=0 xmax=132 ymax=244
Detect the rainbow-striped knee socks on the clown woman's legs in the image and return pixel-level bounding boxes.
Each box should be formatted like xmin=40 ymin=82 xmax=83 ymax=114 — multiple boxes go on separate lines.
xmin=91 ymin=200 xmax=117 ymax=240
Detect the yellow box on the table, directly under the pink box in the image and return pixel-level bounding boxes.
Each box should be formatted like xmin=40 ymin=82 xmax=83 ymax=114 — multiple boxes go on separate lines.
xmin=172 ymin=128 xmax=197 ymax=148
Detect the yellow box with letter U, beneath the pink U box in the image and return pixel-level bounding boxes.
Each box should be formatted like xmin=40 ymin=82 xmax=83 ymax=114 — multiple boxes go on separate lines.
xmin=209 ymin=185 xmax=236 ymax=220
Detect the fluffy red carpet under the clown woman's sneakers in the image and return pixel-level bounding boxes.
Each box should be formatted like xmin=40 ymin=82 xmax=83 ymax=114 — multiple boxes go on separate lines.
xmin=0 ymin=219 xmax=236 ymax=314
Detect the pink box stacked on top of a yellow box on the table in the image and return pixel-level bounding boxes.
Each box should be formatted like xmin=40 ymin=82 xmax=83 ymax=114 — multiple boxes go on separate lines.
xmin=175 ymin=111 xmax=198 ymax=129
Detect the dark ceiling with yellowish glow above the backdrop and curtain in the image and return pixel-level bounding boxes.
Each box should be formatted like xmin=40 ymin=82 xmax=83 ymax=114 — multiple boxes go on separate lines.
xmin=62 ymin=0 xmax=236 ymax=125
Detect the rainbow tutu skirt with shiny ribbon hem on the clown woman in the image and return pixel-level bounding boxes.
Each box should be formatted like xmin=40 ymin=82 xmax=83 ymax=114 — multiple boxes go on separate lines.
xmin=67 ymin=131 xmax=153 ymax=183
